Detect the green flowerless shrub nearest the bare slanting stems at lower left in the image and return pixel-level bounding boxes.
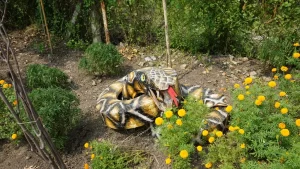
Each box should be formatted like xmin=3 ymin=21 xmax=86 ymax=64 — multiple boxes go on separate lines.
xmin=29 ymin=88 xmax=80 ymax=149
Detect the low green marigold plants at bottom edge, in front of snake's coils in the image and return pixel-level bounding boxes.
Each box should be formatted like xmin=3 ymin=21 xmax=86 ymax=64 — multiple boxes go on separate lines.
xmin=84 ymin=141 xmax=151 ymax=169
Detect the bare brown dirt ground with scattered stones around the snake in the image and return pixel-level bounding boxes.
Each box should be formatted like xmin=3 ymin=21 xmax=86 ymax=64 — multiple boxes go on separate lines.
xmin=0 ymin=27 xmax=267 ymax=169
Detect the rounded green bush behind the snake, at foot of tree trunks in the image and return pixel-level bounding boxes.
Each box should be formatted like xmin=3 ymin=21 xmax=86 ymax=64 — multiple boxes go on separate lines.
xmin=79 ymin=43 xmax=123 ymax=75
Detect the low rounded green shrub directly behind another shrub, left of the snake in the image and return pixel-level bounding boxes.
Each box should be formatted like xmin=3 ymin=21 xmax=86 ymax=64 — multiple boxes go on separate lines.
xmin=26 ymin=64 xmax=69 ymax=89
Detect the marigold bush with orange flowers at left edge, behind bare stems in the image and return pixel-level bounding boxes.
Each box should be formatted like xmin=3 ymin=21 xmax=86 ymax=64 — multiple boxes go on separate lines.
xmin=0 ymin=80 xmax=22 ymax=139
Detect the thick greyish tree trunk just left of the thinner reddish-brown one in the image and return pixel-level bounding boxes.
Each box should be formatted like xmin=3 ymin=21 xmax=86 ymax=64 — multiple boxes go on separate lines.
xmin=91 ymin=1 xmax=101 ymax=43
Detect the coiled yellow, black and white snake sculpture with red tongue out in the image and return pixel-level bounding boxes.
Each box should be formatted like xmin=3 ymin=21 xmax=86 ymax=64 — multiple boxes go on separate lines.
xmin=96 ymin=67 xmax=228 ymax=134
